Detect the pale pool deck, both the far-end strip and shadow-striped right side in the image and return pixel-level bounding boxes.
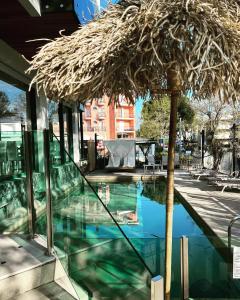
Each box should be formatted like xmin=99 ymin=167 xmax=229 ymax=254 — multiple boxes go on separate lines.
xmin=87 ymin=169 xmax=240 ymax=246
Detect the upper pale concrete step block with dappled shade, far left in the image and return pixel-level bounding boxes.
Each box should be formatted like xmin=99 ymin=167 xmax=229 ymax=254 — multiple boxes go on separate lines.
xmin=0 ymin=235 xmax=55 ymax=300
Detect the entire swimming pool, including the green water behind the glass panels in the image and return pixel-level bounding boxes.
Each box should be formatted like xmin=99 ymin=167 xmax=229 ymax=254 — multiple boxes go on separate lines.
xmin=38 ymin=180 xmax=240 ymax=300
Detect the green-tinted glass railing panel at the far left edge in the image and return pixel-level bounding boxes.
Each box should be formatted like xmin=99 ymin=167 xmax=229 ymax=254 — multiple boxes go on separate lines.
xmin=0 ymin=131 xmax=28 ymax=234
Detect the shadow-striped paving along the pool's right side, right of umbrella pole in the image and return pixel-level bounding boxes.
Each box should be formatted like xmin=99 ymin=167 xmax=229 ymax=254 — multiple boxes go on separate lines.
xmin=172 ymin=170 xmax=240 ymax=246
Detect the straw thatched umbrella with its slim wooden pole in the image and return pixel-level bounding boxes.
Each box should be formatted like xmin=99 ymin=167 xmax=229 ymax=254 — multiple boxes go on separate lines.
xmin=29 ymin=0 xmax=240 ymax=299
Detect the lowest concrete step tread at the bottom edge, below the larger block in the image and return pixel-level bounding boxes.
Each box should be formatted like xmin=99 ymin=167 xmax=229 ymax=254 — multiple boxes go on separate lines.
xmin=9 ymin=282 xmax=76 ymax=300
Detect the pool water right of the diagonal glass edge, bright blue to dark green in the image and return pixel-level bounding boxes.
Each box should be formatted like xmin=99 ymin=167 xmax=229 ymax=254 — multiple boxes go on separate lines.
xmin=91 ymin=181 xmax=240 ymax=299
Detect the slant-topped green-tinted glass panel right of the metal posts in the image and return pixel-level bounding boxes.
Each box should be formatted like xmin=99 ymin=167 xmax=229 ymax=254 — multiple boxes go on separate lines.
xmin=48 ymin=135 xmax=152 ymax=299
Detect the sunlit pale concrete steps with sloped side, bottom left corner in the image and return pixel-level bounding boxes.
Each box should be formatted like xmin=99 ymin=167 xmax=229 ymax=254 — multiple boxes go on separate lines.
xmin=0 ymin=235 xmax=84 ymax=300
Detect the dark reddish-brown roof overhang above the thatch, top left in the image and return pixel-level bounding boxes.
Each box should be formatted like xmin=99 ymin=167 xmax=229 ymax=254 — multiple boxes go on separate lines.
xmin=0 ymin=0 xmax=79 ymax=58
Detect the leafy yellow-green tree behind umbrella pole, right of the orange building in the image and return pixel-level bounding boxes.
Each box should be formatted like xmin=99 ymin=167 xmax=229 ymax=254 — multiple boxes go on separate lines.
xmin=140 ymin=96 xmax=195 ymax=139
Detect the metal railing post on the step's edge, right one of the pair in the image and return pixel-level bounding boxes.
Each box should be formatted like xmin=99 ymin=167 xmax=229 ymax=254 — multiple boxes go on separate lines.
xmin=43 ymin=129 xmax=53 ymax=255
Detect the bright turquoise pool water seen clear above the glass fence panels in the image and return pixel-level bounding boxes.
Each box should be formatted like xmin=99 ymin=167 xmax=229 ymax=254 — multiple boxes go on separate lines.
xmin=90 ymin=181 xmax=204 ymax=238
